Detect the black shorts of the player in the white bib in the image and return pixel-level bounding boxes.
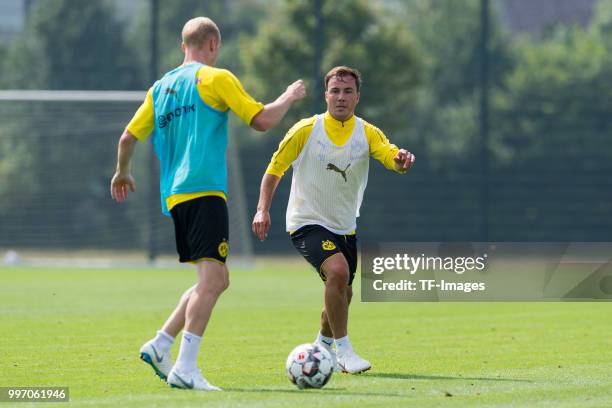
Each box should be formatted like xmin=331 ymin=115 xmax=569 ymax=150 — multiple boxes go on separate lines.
xmin=291 ymin=225 xmax=357 ymax=286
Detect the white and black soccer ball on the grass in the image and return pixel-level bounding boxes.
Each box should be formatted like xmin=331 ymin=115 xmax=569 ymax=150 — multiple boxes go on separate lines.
xmin=286 ymin=343 xmax=334 ymax=389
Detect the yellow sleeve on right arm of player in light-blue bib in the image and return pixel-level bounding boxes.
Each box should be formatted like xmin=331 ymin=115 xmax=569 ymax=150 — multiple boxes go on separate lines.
xmin=198 ymin=66 xmax=264 ymax=126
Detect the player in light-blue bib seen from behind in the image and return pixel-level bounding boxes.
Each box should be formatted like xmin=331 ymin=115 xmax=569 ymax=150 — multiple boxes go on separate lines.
xmin=111 ymin=17 xmax=305 ymax=391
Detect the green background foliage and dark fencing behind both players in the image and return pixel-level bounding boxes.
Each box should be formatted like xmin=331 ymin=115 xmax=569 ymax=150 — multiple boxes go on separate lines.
xmin=0 ymin=0 xmax=612 ymax=247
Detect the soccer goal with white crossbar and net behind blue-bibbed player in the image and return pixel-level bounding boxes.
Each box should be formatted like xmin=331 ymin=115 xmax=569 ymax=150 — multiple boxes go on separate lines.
xmin=0 ymin=90 xmax=253 ymax=263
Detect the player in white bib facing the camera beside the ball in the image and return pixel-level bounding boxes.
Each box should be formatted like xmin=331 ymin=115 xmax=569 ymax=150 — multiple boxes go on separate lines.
xmin=253 ymin=66 xmax=415 ymax=373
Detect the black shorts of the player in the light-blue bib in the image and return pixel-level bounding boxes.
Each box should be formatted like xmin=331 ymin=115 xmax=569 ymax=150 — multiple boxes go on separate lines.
xmin=170 ymin=196 xmax=229 ymax=263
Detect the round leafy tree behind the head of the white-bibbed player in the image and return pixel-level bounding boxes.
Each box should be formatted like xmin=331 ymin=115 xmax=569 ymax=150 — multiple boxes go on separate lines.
xmin=241 ymin=0 xmax=422 ymax=140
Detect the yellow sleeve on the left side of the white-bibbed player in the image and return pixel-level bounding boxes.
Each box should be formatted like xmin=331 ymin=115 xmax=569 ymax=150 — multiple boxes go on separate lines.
xmin=266 ymin=116 xmax=315 ymax=177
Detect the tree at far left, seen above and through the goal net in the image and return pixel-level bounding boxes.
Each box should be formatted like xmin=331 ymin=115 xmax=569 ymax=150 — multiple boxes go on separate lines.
xmin=0 ymin=0 xmax=137 ymax=244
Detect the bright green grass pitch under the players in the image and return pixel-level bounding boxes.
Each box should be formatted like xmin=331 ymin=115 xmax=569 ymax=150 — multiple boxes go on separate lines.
xmin=0 ymin=262 xmax=612 ymax=407
